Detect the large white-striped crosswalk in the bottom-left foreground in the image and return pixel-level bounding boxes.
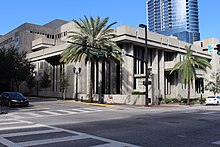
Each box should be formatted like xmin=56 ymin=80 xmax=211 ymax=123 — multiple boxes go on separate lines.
xmin=0 ymin=119 xmax=138 ymax=147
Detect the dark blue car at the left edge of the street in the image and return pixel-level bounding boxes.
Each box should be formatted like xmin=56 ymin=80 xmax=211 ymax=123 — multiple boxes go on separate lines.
xmin=0 ymin=92 xmax=29 ymax=107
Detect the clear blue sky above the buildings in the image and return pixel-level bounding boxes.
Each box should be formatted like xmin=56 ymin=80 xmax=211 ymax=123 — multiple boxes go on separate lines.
xmin=0 ymin=0 xmax=220 ymax=39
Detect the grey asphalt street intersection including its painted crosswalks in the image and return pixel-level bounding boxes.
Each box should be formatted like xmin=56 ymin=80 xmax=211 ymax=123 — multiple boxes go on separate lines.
xmin=0 ymin=100 xmax=220 ymax=147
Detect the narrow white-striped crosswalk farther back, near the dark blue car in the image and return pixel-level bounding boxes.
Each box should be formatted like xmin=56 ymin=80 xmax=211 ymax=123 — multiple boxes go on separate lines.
xmin=7 ymin=107 xmax=113 ymax=119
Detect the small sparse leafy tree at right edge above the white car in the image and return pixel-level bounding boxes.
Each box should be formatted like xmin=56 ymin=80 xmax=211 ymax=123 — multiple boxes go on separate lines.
xmin=205 ymin=72 xmax=220 ymax=95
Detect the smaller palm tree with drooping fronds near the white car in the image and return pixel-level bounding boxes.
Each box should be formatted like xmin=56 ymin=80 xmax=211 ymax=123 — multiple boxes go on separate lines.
xmin=170 ymin=45 xmax=212 ymax=104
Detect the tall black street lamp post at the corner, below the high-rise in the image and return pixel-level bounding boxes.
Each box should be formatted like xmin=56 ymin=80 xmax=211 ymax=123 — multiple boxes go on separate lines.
xmin=139 ymin=24 xmax=149 ymax=106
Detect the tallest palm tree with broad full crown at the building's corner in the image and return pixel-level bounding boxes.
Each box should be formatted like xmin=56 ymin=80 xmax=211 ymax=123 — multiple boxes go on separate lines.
xmin=60 ymin=16 xmax=121 ymax=101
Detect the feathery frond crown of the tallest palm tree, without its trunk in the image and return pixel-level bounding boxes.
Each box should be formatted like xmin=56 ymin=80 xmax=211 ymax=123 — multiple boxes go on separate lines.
xmin=60 ymin=16 xmax=122 ymax=63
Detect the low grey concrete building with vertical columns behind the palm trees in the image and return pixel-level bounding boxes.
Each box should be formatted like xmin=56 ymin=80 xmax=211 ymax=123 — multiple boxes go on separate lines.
xmin=0 ymin=20 xmax=219 ymax=105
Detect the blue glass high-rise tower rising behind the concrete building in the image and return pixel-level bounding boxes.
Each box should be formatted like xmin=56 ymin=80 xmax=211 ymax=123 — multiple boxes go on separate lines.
xmin=146 ymin=0 xmax=200 ymax=43
